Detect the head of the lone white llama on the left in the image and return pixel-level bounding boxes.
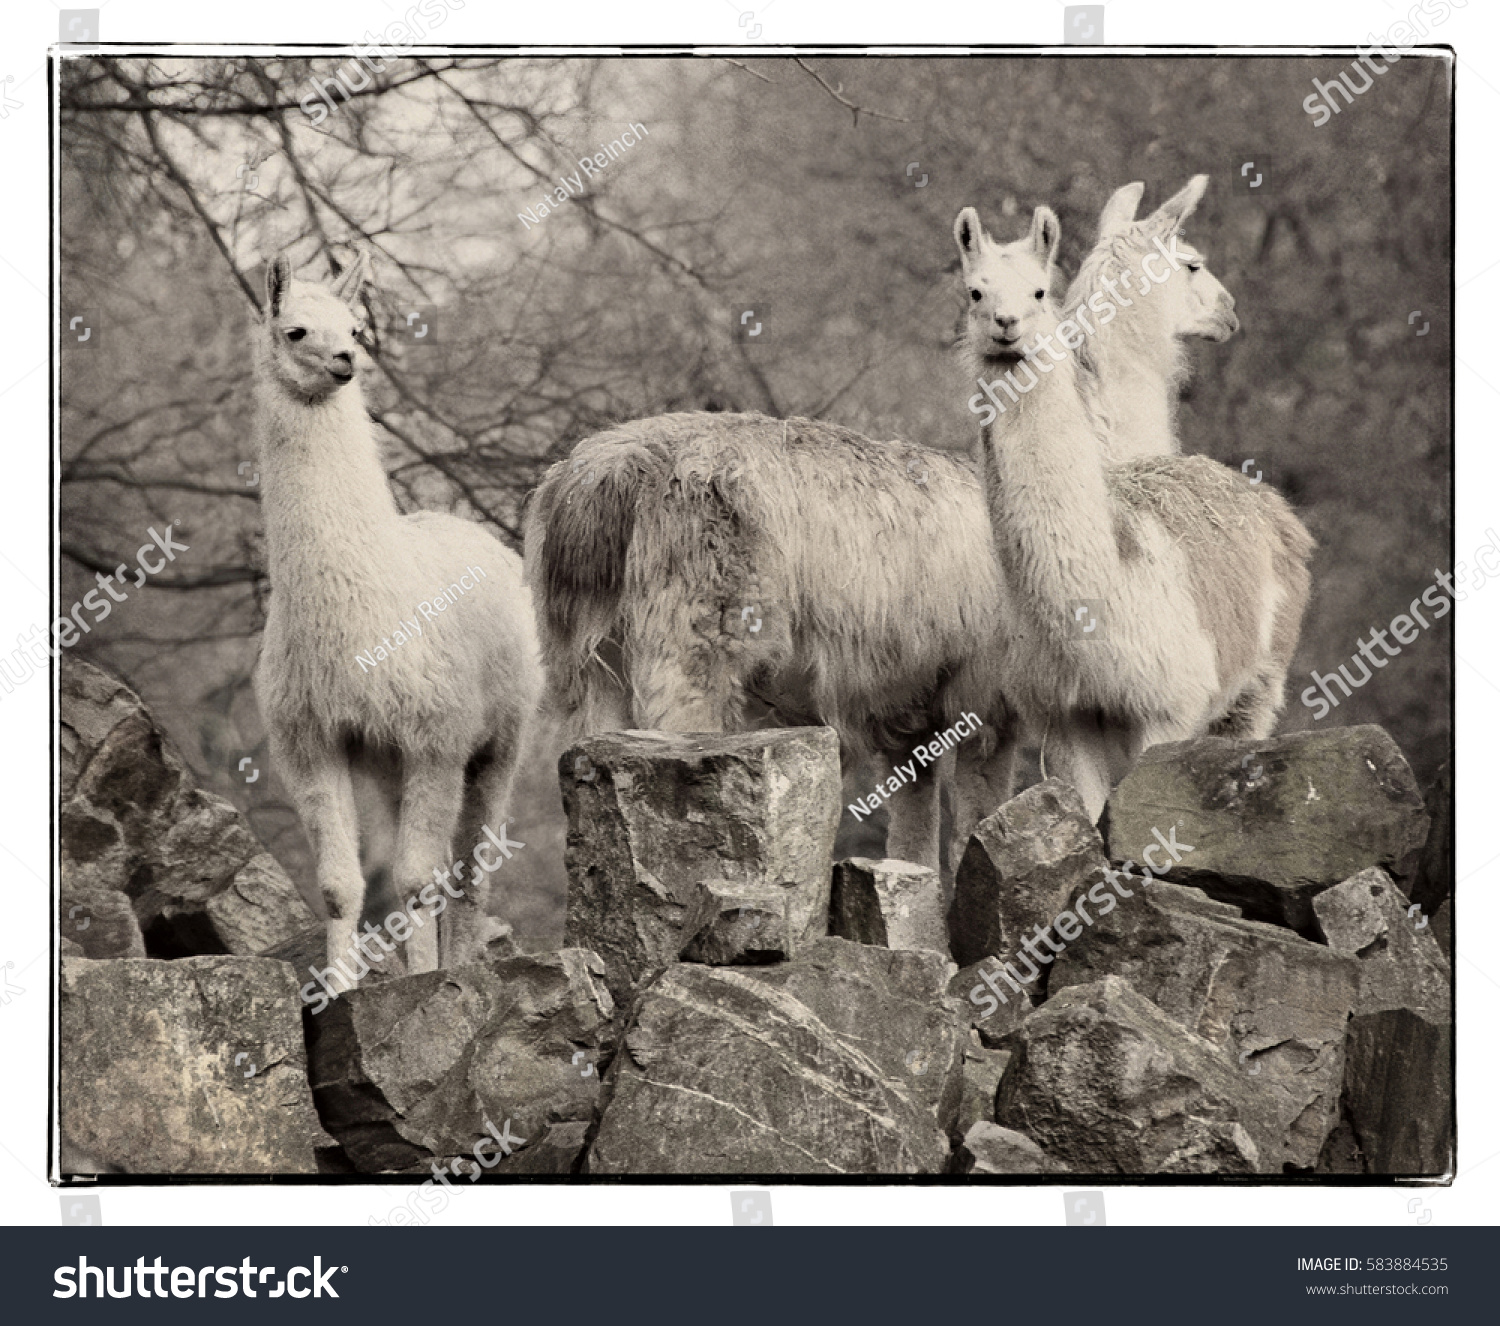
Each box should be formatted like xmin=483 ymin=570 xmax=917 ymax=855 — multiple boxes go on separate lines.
xmin=261 ymin=254 xmax=366 ymax=401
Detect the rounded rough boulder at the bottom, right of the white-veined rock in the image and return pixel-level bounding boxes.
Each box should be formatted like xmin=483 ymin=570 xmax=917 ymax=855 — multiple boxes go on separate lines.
xmin=995 ymin=977 xmax=1262 ymax=1175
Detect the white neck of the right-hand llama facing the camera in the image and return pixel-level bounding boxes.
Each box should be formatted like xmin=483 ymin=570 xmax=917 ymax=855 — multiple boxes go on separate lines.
xmin=980 ymin=346 xmax=1118 ymax=606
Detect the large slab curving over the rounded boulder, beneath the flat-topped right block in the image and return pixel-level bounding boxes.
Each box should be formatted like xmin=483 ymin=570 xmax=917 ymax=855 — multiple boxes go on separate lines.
xmin=1049 ymin=882 xmax=1359 ymax=1173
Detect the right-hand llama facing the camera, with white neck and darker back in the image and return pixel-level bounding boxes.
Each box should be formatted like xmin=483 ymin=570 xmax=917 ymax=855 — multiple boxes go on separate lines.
xmin=954 ymin=207 xmax=1313 ymax=819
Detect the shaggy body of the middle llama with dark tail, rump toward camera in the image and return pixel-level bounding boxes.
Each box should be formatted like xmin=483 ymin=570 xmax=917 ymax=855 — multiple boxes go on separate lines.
xmin=527 ymin=414 xmax=1011 ymax=867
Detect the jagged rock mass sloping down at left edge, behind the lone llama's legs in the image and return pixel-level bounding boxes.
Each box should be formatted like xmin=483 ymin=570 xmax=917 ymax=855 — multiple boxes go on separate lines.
xmin=59 ymin=654 xmax=315 ymax=957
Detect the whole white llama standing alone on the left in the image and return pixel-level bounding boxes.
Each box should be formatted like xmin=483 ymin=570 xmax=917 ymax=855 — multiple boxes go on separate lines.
xmin=255 ymin=255 xmax=542 ymax=989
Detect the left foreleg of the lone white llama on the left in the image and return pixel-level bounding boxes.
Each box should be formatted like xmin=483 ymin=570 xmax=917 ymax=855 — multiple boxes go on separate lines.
xmin=272 ymin=732 xmax=368 ymax=995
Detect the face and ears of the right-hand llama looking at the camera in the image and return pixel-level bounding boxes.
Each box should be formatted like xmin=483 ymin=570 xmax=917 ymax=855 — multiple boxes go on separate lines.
xmin=953 ymin=207 xmax=1062 ymax=363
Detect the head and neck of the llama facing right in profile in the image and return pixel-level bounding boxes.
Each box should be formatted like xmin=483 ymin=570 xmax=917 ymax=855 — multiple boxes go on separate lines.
xmin=1064 ymin=176 xmax=1239 ymax=461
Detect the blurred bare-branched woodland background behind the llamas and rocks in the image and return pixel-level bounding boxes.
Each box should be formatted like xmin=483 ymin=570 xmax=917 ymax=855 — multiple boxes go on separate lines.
xmin=59 ymin=56 xmax=1463 ymax=942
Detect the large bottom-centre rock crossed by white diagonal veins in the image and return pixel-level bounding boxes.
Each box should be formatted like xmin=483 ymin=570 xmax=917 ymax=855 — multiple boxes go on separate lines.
xmin=587 ymin=939 xmax=959 ymax=1175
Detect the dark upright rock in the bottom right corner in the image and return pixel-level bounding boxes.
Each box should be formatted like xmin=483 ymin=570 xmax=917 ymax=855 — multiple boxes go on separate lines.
xmin=1344 ymin=1008 xmax=1454 ymax=1178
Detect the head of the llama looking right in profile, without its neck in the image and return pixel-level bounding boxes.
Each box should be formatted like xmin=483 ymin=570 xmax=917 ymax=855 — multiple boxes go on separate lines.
xmin=1076 ymin=176 xmax=1239 ymax=341
